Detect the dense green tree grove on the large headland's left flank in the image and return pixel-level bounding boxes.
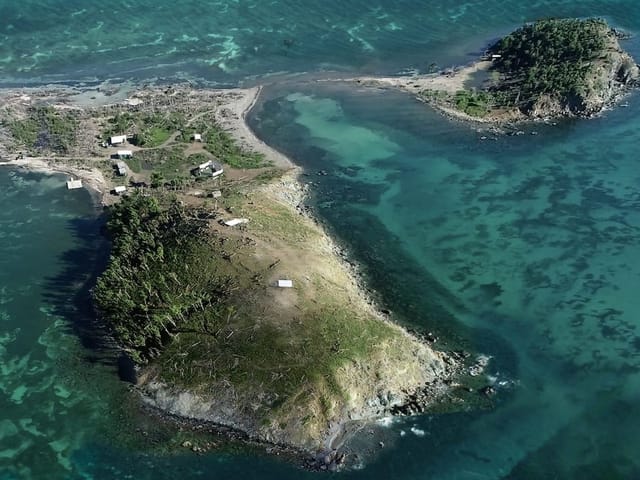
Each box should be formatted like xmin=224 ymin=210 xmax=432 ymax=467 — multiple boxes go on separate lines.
xmin=94 ymin=194 xmax=232 ymax=362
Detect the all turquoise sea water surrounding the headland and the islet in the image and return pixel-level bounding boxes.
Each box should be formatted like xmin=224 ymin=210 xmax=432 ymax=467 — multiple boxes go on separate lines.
xmin=0 ymin=0 xmax=640 ymax=480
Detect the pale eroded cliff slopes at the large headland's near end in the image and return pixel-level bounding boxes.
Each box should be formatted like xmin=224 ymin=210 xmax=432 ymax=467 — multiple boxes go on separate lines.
xmin=137 ymin=327 xmax=462 ymax=457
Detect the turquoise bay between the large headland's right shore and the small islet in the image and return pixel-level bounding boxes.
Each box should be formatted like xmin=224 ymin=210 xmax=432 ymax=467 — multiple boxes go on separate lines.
xmin=248 ymin=85 xmax=640 ymax=478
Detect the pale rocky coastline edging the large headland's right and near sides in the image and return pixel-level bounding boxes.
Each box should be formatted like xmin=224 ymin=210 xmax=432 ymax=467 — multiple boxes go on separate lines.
xmin=136 ymin=162 xmax=464 ymax=471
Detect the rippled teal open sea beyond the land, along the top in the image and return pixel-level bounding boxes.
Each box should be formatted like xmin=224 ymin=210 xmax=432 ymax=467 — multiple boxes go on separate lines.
xmin=0 ymin=0 xmax=640 ymax=85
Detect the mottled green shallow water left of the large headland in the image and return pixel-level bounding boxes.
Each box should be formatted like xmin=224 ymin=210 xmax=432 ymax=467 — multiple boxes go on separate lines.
xmin=0 ymin=172 xmax=117 ymax=478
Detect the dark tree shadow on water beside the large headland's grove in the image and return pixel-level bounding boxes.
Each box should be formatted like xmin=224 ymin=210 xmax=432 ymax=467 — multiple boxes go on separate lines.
xmin=43 ymin=214 xmax=135 ymax=382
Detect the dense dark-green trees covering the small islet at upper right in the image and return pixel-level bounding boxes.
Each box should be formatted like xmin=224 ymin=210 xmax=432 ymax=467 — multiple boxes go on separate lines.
xmin=489 ymin=19 xmax=610 ymax=107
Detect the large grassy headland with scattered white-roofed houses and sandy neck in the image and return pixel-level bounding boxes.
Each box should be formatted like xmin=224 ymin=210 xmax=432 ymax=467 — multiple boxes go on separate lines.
xmin=0 ymin=86 xmax=486 ymax=470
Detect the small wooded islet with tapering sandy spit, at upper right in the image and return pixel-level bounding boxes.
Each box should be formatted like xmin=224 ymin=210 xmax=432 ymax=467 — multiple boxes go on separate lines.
xmin=359 ymin=18 xmax=639 ymax=123
